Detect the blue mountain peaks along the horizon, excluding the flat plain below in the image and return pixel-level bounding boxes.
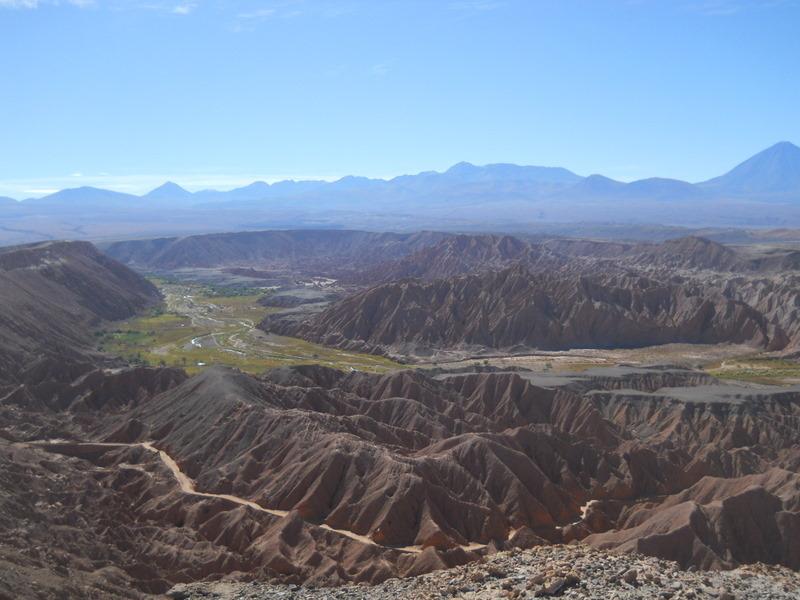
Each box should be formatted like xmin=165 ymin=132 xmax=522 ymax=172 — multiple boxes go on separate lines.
xmin=10 ymin=142 xmax=800 ymax=206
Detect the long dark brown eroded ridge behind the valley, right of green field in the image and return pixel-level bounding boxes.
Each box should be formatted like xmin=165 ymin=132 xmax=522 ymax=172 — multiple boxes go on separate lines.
xmin=262 ymin=267 xmax=789 ymax=354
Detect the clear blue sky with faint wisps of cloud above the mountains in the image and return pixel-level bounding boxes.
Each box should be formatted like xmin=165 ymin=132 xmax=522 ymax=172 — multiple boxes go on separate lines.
xmin=0 ymin=0 xmax=800 ymax=197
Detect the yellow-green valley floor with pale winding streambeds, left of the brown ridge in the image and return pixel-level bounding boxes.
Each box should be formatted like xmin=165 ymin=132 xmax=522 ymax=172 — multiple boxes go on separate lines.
xmin=97 ymin=280 xmax=403 ymax=373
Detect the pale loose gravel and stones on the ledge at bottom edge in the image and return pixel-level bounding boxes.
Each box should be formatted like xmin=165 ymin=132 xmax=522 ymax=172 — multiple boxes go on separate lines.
xmin=167 ymin=545 xmax=800 ymax=600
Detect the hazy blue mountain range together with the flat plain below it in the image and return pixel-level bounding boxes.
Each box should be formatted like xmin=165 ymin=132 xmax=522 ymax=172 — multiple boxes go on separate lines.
xmin=0 ymin=142 xmax=800 ymax=244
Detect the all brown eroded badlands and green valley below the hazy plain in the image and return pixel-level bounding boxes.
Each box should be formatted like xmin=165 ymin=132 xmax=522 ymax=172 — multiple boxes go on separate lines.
xmin=0 ymin=231 xmax=800 ymax=599
